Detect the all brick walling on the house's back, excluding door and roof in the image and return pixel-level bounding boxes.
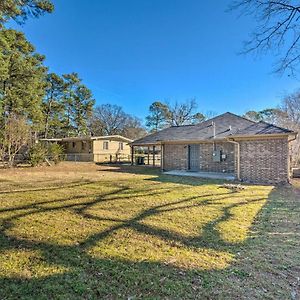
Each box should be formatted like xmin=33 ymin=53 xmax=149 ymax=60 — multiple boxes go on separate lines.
xmin=164 ymin=138 xmax=289 ymax=184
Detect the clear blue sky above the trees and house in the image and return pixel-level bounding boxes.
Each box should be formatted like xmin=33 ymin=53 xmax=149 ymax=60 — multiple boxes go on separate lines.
xmin=7 ymin=0 xmax=299 ymax=118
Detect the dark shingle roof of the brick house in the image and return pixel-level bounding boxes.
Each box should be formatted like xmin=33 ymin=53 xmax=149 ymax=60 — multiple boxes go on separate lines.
xmin=132 ymin=112 xmax=292 ymax=146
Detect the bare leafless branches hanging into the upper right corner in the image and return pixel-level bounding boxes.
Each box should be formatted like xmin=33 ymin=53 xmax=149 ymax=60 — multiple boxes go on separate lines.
xmin=230 ymin=0 xmax=300 ymax=74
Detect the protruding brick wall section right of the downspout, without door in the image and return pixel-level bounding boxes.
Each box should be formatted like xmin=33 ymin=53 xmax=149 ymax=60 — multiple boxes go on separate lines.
xmin=239 ymin=138 xmax=289 ymax=184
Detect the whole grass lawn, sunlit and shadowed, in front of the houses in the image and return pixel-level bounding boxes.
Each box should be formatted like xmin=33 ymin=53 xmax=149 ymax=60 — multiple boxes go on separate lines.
xmin=0 ymin=163 xmax=300 ymax=299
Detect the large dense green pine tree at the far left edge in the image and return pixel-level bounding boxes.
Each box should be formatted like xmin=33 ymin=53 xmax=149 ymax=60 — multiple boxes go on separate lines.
xmin=0 ymin=29 xmax=47 ymax=129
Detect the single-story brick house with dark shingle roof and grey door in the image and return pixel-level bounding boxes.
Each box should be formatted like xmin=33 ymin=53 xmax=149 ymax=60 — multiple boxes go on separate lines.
xmin=131 ymin=112 xmax=297 ymax=184
